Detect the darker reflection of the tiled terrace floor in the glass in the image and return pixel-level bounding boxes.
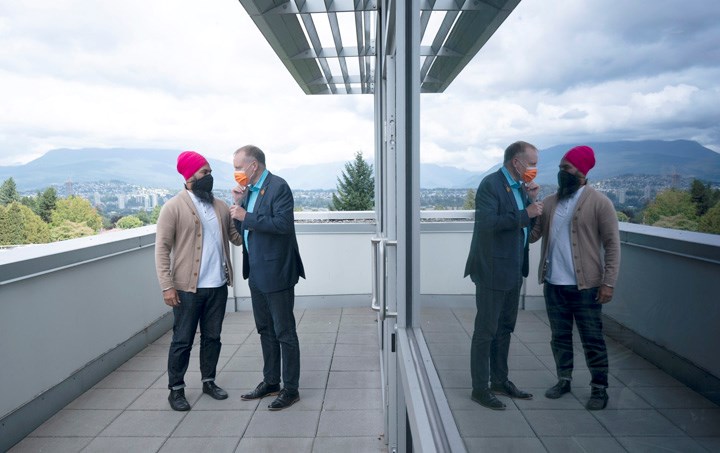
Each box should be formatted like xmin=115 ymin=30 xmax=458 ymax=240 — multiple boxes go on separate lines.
xmin=423 ymin=308 xmax=720 ymax=453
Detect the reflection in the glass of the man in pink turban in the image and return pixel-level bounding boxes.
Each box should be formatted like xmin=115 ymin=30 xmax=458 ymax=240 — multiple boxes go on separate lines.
xmin=530 ymin=146 xmax=620 ymax=410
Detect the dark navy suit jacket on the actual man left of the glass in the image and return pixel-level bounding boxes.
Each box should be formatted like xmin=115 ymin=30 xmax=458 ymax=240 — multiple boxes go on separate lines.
xmin=235 ymin=172 xmax=305 ymax=293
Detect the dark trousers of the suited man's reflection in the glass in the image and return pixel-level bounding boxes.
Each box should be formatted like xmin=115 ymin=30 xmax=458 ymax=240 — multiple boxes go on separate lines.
xmin=470 ymin=282 xmax=522 ymax=391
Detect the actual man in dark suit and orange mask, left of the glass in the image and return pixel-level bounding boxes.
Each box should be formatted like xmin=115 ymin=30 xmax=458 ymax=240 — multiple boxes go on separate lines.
xmin=230 ymin=145 xmax=305 ymax=410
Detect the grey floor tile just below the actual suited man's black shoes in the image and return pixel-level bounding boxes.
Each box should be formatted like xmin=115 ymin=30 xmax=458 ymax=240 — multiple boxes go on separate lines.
xmin=243 ymin=410 xmax=320 ymax=438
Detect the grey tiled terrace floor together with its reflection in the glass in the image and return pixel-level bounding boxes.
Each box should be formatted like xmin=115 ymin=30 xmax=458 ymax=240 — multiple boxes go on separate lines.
xmin=10 ymin=308 xmax=720 ymax=453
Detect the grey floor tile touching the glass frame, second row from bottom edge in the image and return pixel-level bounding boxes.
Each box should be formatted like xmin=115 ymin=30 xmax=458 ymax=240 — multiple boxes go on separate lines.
xmin=317 ymin=410 xmax=384 ymax=437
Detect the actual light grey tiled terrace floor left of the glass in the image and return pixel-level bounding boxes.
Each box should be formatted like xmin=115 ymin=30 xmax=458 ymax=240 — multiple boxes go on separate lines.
xmin=11 ymin=308 xmax=387 ymax=453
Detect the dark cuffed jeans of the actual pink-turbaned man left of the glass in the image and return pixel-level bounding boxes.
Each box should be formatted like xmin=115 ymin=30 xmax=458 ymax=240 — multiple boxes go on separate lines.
xmin=168 ymin=285 xmax=227 ymax=390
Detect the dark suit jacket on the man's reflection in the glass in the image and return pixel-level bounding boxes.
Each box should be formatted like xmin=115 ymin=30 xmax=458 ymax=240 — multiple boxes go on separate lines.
xmin=465 ymin=169 xmax=535 ymax=291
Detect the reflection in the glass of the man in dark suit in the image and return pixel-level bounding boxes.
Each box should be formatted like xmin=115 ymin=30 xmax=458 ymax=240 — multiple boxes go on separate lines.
xmin=465 ymin=141 xmax=542 ymax=409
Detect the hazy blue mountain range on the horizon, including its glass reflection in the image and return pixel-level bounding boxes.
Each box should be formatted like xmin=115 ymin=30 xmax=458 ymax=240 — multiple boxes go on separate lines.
xmin=0 ymin=140 xmax=720 ymax=192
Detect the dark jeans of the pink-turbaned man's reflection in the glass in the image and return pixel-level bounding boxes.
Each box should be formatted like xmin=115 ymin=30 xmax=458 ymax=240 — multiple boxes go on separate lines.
xmin=543 ymin=283 xmax=608 ymax=387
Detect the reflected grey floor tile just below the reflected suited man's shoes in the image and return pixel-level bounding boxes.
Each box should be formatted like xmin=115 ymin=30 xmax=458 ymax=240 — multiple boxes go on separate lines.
xmin=453 ymin=405 xmax=535 ymax=438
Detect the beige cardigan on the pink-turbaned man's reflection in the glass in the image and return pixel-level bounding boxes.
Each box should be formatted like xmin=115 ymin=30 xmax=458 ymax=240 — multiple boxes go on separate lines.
xmin=530 ymin=186 xmax=620 ymax=289
